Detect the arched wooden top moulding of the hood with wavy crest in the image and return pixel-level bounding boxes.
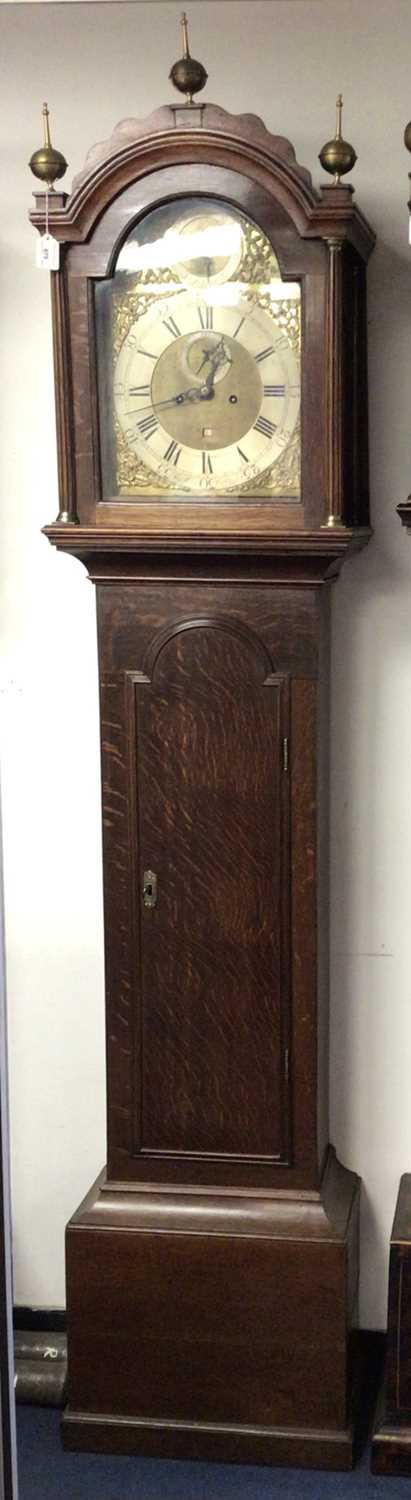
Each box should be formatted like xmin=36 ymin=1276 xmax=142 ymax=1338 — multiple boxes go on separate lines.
xmin=30 ymin=104 xmax=375 ymax=260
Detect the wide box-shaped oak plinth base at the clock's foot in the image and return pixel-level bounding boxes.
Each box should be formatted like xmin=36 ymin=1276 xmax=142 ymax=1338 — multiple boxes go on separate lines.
xmin=63 ymin=1152 xmax=360 ymax=1469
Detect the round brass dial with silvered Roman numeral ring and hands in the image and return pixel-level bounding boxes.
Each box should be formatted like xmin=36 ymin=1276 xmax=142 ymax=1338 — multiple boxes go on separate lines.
xmin=114 ymin=290 xmax=300 ymax=492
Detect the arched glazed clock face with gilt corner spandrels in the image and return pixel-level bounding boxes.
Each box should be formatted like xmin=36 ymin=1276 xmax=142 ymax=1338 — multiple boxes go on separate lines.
xmin=96 ymin=197 xmax=300 ymax=503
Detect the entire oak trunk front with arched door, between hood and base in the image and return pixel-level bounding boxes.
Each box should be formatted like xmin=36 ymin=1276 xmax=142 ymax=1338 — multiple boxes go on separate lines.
xmin=98 ymin=579 xmax=326 ymax=1188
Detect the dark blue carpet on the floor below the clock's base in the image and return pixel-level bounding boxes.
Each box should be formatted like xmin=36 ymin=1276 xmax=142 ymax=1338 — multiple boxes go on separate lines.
xmin=18 ymin=1407 xmax=411 ymax=1500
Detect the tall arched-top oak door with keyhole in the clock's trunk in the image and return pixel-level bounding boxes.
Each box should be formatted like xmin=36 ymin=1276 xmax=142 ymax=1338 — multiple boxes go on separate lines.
xmin=123 ymin=618 xmax=290 ymax=1182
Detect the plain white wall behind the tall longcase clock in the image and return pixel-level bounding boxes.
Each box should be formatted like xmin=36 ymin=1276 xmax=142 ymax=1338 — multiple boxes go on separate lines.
xmin=0 ymin=0 xmax=411 ymax=1328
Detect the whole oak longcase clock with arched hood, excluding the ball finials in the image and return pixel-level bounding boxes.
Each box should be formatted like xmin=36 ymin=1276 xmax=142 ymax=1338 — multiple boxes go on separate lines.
xmin=32 ymin=105 xmax=374 ymax=1467
